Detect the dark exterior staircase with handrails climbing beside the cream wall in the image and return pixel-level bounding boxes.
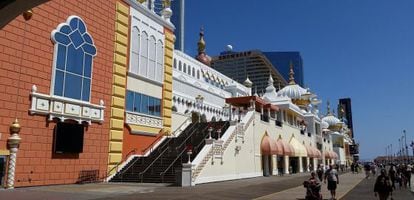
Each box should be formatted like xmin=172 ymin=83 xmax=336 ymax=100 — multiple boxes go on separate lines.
xmin=110 ymin=122 xmax=230 ymax=183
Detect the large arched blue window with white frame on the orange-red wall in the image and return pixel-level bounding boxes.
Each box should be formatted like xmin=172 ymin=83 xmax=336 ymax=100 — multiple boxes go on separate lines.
xmin=51 ymin=16 xmax=96 ymax=102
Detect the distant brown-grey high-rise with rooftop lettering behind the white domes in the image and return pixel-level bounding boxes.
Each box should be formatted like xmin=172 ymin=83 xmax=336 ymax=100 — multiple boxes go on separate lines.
xmin=211 ymin=49 xmax=288 ymax=94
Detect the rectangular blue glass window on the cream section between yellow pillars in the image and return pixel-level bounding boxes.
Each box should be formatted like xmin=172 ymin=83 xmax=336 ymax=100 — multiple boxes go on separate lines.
xmin=125 ymin=90 xmax=161 ymax=117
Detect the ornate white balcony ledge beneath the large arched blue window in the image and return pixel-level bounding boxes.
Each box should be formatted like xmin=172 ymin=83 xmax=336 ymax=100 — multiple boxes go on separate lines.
xmin=29 ymin=85 xmax=105 ymax=124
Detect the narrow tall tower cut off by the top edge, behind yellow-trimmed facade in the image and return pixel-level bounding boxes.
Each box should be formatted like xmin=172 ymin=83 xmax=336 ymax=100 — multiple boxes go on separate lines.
xmin=171 ymin=0 xmax=185 ymax=52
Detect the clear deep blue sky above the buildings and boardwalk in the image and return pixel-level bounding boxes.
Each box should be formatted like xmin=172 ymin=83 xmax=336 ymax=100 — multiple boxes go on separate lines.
xmin=185 ymin=0 xmax=414 ymax=159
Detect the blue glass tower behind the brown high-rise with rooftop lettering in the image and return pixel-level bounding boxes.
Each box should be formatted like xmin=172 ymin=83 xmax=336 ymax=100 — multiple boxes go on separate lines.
xmin=263 ymin=51 xmax=305 ymax=88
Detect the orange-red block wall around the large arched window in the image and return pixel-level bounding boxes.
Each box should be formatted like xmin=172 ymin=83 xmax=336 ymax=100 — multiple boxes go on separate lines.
xmin=0 ymin=0 xmax=115 ymax=187
